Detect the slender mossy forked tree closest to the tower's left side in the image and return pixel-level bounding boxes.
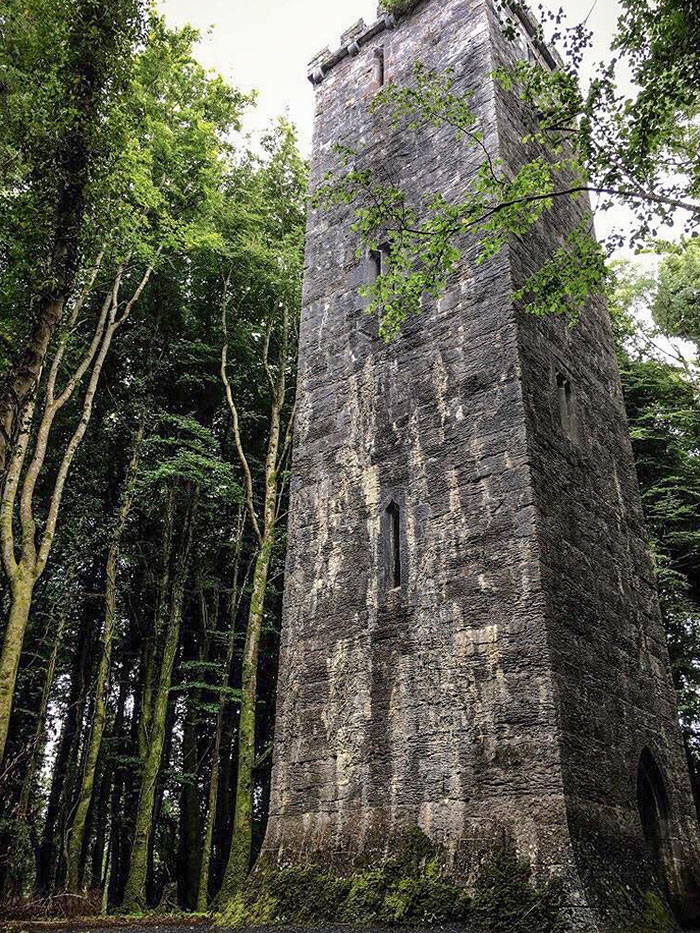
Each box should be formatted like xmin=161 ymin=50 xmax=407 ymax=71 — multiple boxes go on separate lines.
xmin=219 ymin=122 xmax=305 ymax=900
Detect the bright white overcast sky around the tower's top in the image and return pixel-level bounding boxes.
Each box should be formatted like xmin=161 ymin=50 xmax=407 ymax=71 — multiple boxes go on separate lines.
xmin=160 ymin=0 xmax=618 ymax=154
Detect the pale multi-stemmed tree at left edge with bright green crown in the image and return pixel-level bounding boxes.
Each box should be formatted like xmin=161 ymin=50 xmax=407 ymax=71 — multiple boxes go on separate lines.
xmin=0 ymin=19 xmax=246 ymax=761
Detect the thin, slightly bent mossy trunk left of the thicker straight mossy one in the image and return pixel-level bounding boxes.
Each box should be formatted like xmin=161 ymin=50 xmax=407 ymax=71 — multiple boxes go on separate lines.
xmin=66 ymin=420 xmax=145 ymax=894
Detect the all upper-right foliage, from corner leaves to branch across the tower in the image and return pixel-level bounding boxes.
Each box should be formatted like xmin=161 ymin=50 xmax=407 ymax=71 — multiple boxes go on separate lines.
xmin=316 ymin=0 xmax=700 ymax=339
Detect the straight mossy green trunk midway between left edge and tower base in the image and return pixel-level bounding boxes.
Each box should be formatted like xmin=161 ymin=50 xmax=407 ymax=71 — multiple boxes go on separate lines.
xmin=122 ymin=492 xmax=197 ymax=913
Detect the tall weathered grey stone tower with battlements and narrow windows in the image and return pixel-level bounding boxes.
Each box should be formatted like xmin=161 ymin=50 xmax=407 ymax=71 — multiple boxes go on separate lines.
xmin=265 ymin=0 xmax=700 ymax=931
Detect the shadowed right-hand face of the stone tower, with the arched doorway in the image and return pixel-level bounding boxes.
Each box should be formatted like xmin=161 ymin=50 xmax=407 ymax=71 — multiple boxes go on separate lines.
xmin=493 ymin=10 xmax=700 ymax=915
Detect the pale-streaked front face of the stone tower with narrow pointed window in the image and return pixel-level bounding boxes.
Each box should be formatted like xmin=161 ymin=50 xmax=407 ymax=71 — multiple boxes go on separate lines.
xmin=266 ymin=0 xmax=565 ymax=872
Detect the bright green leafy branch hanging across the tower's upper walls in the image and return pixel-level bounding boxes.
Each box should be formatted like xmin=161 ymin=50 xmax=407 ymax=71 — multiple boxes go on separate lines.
xmin=314 ymin=63 xmax=606 ymax=339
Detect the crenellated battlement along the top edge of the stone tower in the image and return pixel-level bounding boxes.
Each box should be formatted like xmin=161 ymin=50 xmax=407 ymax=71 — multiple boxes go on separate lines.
xmin=308 ymin=0 xmax=562 ymax=87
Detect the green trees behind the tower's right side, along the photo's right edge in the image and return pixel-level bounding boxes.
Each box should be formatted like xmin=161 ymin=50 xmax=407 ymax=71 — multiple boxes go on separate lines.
xmin=611 ymin=240 xmax=700 ymax=759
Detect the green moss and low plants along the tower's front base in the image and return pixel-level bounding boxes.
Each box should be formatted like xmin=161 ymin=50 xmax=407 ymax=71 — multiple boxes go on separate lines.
xmin=217 ymin=834 xmax=566 ymax=933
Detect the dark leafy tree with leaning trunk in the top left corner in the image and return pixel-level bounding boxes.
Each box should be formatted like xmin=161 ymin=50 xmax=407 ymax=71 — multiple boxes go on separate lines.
xmin=0 ymin=0 xmax=145 ymax=476
